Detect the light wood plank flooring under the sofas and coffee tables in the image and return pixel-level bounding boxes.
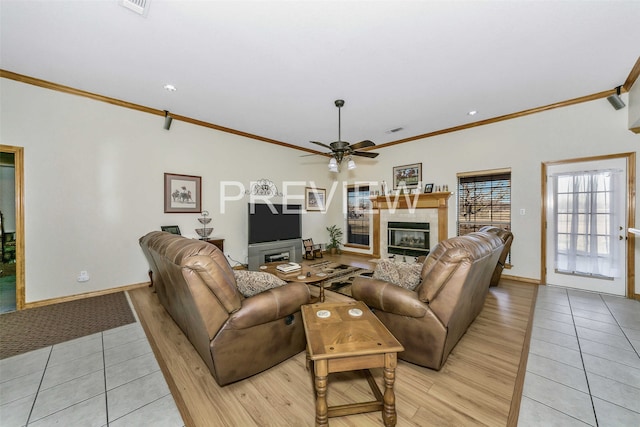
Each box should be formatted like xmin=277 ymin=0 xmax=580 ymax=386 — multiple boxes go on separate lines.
xmin=129 ymin=257 xmax=536 ymax=426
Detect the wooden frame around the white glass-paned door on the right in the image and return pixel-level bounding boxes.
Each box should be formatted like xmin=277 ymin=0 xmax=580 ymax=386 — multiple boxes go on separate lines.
xmin=540 ymin=152 xmax=640 ymax=299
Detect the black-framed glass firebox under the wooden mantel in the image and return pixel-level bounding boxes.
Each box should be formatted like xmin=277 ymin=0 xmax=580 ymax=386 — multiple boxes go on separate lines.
xmin=387 ymin=222 xmax=429 ymax=257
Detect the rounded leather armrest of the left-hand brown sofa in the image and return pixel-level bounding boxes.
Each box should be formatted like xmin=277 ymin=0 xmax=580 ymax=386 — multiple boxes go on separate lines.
xmin=227 ymin=282 xmax=311 ymax=329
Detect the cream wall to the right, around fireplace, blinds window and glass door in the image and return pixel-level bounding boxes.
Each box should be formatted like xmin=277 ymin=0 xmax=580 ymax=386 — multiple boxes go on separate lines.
xmin=332 ymin=95 xmax=640 ymax=282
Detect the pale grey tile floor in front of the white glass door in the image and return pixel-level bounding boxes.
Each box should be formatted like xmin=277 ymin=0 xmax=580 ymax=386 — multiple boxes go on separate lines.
xmin=518 ymin=286 xmax=640 ymax=427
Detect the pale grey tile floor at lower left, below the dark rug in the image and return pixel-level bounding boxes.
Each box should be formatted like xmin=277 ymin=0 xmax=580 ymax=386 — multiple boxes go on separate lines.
xmin=0 ymin=298 xmax=184 ymax=427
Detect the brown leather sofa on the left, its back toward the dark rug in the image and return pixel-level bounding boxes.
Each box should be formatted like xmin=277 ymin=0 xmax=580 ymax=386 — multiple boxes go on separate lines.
xmin=140 ymin=231 xmax=310 ymax=386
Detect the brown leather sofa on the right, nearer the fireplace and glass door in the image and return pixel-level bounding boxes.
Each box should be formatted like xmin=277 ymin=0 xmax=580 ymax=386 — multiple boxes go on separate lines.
xmin=351 ymin=232 xmax=504 ymax=370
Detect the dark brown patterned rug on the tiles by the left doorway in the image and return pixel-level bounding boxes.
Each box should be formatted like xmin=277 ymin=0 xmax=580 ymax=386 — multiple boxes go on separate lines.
xmin=0 ymin=292 xmax=136 ymax=360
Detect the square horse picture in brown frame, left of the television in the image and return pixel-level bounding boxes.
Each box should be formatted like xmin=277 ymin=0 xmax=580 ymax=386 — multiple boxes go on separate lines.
xmin=164 ymin=173 xmax=202 ymax=213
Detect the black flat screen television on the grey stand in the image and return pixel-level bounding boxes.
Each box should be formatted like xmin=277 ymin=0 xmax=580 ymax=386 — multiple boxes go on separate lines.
xmin=248 ymin=203 xmax=302 ymax=245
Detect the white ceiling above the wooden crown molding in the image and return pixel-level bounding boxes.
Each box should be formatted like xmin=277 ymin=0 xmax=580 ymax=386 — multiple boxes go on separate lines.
xmin=0 ymin=0 xmax=640 ymax=157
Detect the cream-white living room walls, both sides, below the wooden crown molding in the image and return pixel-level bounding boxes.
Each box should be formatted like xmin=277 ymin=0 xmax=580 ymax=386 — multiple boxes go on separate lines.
xmin=0 ymin=79 xmax=640 ymax=302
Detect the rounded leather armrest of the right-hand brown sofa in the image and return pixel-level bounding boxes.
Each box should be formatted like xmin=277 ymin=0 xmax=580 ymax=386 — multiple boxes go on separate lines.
xmin=351 ymin=276 xmax=427 ymax=317
